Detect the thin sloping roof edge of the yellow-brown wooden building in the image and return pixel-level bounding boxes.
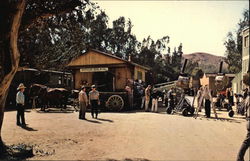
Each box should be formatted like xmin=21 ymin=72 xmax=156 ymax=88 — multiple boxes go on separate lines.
xmin=68 ymin=49 xmax=150 ymax=70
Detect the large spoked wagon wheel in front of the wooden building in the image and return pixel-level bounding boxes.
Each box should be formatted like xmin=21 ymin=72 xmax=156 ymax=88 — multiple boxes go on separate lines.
xmin=106 ymin=95 xmax=124 ymax=111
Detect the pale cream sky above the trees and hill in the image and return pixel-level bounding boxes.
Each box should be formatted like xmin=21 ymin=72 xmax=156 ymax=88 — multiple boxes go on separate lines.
xmin=92 ymin=0 xmax=249 ymax=56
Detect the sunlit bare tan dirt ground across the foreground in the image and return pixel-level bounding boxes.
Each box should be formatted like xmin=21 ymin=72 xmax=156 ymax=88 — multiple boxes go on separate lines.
xmin=2 ymin=105 xmax=249 ymax=161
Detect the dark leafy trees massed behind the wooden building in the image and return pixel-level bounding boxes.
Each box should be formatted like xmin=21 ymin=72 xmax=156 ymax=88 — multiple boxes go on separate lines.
xmin=19 ymin=1 xmax=183 ymax=83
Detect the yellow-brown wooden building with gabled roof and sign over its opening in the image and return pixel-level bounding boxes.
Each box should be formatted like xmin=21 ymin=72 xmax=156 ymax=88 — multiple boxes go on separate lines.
xmin=67 ymin=49 xmax=149 ymax=91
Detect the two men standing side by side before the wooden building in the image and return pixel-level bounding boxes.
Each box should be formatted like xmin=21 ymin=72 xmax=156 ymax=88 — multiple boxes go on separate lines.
xmin=78 ymin=85 xmax=100 ymax=120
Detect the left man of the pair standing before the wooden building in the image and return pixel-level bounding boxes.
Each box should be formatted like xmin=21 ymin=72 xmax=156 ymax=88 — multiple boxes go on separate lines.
xmin=78 ymin=86 xmax=88 ymax=120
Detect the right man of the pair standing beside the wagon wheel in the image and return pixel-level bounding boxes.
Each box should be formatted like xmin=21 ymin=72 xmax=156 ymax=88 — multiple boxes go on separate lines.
xmin=89 ymin=85 xmax=100 ymax=119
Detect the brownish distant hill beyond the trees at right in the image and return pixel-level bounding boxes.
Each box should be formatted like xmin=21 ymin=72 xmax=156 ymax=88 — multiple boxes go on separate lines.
xmin=182 ymin=52 xmax=228 ymax=73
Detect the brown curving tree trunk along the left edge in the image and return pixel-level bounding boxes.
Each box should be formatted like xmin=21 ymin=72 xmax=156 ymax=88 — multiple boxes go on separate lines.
xmin=0 ymin=0 xmax=26 ymax=153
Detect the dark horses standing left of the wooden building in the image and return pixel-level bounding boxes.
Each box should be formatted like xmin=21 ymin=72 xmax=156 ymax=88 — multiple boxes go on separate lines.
xmin=29 ymin=84 xmax=70 ymax=111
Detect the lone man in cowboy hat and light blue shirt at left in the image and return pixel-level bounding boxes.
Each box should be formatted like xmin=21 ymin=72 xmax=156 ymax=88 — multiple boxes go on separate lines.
xmin=16 ymin=83 xmax=26 ymax=126
